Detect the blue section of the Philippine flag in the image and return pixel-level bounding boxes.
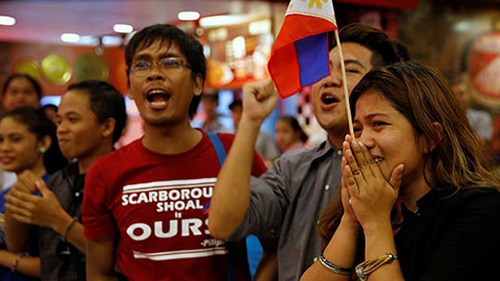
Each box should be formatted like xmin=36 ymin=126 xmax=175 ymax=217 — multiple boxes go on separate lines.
xmin=295 ymin=33 xmax=330 ymax=86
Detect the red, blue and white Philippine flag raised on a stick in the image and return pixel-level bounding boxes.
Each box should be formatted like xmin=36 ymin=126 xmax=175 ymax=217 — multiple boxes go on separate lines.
xmin=268 ymin=0 xmax=337 ymax=98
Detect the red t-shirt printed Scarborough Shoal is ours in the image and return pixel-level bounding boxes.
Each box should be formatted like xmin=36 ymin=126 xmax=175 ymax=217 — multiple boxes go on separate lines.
xmin=82 ymin=133 xmax=265 ymax=281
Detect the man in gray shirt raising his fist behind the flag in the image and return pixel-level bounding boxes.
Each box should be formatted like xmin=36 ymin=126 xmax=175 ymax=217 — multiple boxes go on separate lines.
xmin=209 ymin=24 xmax=409 ymax=280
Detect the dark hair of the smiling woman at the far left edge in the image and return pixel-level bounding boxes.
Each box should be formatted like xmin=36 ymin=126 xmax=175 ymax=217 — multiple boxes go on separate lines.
xmin=1 ymin=106 xmax=68 ymax=174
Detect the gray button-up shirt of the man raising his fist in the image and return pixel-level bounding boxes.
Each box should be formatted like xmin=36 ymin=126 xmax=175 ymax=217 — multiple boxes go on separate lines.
xmin=231 ymin=141 xmax=342 ymax=280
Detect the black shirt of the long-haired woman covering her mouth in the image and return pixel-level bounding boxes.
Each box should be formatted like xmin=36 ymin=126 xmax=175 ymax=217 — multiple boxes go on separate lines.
xmin=395 ymin=188 xmax=500 ymax=281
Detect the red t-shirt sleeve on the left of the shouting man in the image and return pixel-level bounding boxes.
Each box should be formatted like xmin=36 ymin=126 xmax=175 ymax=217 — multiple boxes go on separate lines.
xmin=82 ymin=159 xmax=116 ymax=239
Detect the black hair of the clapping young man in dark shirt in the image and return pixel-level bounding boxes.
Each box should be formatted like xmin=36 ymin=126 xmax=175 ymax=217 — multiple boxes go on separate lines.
xmin=68 ymin=80 xmax=127 ymax=143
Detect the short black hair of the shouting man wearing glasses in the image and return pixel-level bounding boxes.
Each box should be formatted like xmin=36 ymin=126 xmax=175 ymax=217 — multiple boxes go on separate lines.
xmin=125 ymin=24 xmax=207 ymax=116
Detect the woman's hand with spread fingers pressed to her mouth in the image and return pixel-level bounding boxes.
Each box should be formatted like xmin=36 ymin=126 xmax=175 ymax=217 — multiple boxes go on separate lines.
xmin=343 ymin=135 xmax=404 ymax=228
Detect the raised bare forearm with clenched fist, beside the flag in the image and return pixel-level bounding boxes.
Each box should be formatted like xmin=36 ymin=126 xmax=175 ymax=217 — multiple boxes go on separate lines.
xmin=208 ymin=79 xmax=278 ymax=239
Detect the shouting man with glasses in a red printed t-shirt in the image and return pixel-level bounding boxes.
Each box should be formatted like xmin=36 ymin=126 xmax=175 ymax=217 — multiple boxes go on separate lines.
xmin=82 ymin=24 xmax=265 ymax=281
